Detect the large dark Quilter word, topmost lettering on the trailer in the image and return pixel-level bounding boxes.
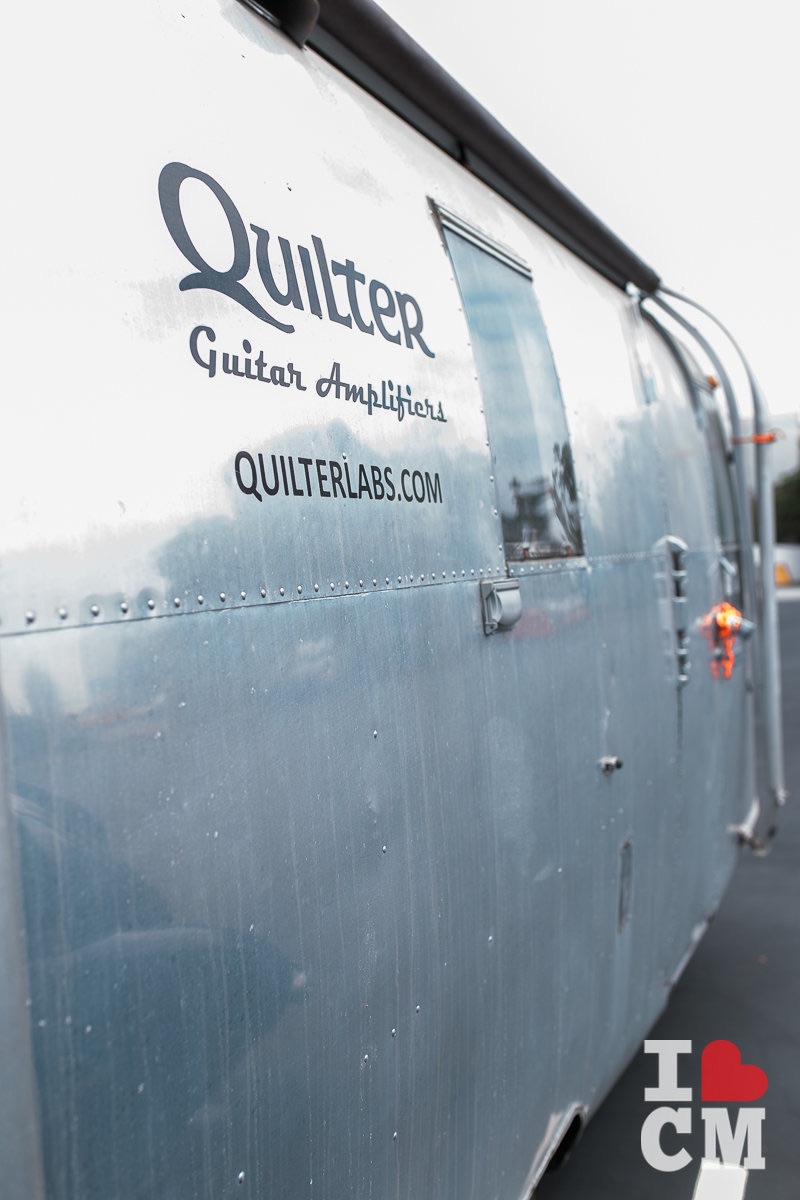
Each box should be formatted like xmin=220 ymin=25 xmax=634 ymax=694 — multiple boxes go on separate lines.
xmin=158 ymin=162 xmax=435 ymax=359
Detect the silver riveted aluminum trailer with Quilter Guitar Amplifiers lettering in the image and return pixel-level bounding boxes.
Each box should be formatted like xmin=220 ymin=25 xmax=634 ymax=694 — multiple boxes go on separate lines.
xmin=0 ymin=0 xmax=782 ymax=1200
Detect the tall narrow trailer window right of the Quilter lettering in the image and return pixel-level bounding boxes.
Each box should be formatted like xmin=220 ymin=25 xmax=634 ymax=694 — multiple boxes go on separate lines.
xmin=438 ymin=210 xmax=583 ymax=574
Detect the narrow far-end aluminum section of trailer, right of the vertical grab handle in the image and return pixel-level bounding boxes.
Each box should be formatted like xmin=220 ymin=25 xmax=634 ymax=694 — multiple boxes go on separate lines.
xmin=639 ymin=312 xmax=752 ymax=967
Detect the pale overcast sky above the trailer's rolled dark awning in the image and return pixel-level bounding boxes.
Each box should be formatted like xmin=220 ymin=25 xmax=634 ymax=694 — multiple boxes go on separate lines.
xmin=380 ymin=0 xmax=800 ymax=424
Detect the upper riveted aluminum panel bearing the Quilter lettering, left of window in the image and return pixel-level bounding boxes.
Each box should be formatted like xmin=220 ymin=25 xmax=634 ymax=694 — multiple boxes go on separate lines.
xmin=0 ymin=4 xmax=501 ymax=630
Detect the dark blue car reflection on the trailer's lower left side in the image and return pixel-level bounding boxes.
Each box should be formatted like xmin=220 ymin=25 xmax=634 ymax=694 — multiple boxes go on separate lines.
xmin=12 ymin=786 xmax=306 ymax=1198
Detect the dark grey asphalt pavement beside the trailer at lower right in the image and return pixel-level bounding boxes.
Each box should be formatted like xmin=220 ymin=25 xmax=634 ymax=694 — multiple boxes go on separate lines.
xmin=536 ymin=589 xmax=800 ymax=1200
